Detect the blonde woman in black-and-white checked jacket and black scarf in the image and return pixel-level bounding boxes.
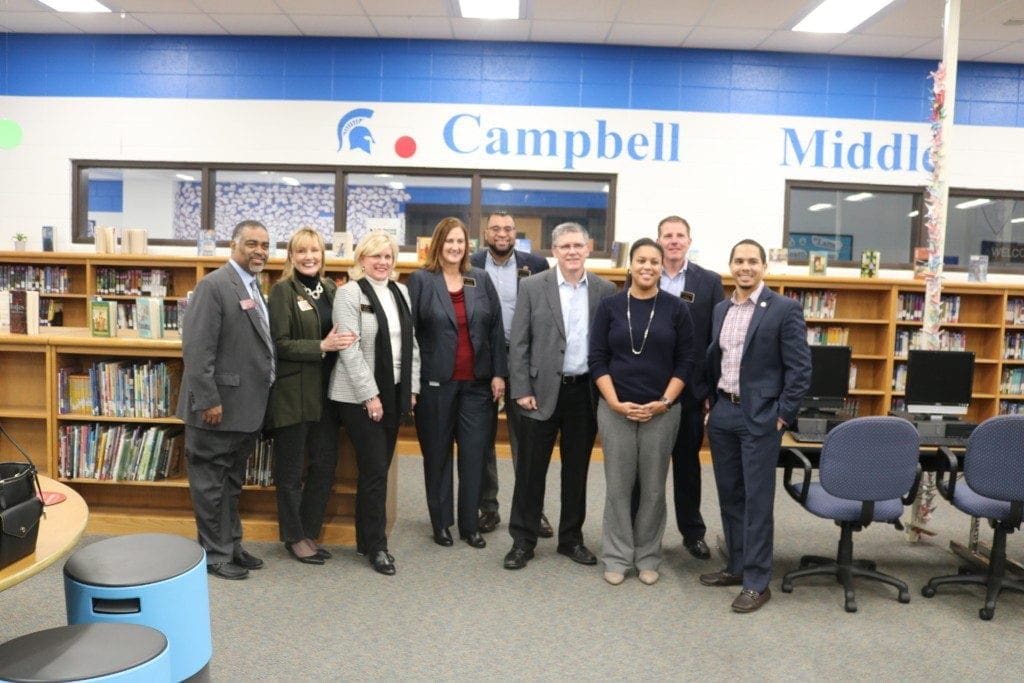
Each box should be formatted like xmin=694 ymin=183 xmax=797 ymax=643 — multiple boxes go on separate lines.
xmin=331 ymin=232 xmax=420 ymax=575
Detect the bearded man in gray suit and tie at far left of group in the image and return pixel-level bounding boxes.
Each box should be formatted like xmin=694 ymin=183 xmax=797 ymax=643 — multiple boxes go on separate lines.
xmin=177 ymin=220 xmax=274 ymax=579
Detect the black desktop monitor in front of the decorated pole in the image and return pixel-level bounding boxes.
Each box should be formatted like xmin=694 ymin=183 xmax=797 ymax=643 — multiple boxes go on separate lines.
xmin=905 ymin=350 xmax=974 ymax=416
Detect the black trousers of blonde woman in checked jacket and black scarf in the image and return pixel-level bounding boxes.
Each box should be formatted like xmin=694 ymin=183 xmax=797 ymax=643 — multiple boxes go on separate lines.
xmin=338 ymin=385 xmax=400 ymax=555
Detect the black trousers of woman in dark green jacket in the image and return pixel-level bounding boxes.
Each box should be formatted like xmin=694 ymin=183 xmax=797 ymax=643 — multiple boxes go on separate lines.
xmin=273 ymin=399 xmax=338 ymax=543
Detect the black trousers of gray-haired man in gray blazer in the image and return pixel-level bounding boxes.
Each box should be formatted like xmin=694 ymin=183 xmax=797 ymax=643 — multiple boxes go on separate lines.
xmin=509 ymin=383 xmax=597 ymax=548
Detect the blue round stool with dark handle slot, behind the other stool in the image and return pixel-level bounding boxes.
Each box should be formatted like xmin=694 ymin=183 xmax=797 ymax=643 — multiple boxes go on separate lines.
xmin=65 ymin=533 xmax=213 ymax=681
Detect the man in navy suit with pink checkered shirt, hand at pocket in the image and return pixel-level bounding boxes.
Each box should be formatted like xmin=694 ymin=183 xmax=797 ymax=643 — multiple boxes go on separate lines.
xmin=700 ymin=240 xmax=811 ymax=612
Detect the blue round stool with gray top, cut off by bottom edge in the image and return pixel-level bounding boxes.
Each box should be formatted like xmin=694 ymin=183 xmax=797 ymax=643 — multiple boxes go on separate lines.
xmin=0 ymin=624 xmax=172 ymax=683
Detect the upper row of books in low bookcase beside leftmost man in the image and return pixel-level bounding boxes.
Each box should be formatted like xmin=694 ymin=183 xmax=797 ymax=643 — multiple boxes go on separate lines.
xmin=57 ymin=360 xmax=181 ymax=418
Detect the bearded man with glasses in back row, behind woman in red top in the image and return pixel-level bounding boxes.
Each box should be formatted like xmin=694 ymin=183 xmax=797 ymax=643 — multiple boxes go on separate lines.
xmin=469 ymin=210 xmax=553 ymax=539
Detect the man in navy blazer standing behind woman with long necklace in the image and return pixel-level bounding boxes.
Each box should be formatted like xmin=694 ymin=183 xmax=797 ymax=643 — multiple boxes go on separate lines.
xmin=657 ymin=216 xmax=724 ymax=560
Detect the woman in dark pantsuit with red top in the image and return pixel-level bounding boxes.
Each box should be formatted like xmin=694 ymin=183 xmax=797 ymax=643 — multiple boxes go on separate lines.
xmin=409 ymin=218 xmax=508 ymax=548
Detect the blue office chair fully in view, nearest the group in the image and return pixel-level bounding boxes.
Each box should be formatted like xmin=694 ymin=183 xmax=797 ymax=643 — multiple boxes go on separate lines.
xmin=782 ymin=417 xmax=921 ymax=612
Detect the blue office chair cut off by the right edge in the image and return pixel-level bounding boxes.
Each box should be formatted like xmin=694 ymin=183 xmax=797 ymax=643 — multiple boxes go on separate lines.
xmin=921 ymin=415 xmax=1024 ymax=621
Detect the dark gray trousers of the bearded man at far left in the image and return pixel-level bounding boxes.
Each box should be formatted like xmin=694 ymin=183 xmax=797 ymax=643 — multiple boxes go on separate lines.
xmin=185 ymin=425 xmax=258 ymax=564
